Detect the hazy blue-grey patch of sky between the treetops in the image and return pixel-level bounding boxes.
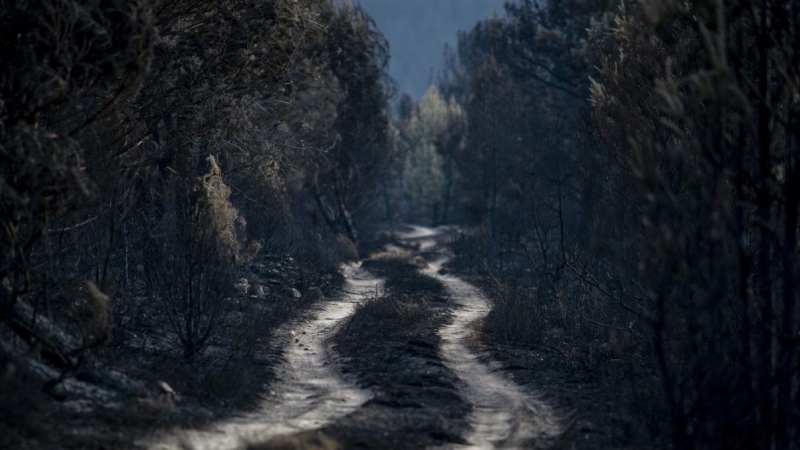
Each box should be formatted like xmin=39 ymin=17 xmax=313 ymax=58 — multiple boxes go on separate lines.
xmin=353 ymin=0 xmax=505 ymax=99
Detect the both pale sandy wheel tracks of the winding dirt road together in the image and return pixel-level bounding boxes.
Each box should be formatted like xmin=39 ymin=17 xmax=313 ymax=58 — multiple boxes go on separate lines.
xmin=152 ymin=226 xmax=563 ymax=450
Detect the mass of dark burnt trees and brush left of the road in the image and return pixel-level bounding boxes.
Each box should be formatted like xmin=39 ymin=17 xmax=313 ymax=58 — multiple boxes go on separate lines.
xmin=0 ymin=0 xmax=392 ymax=438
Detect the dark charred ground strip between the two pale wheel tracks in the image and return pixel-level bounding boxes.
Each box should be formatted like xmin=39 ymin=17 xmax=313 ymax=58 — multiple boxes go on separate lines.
xmin=312 ymin=255 xmax=471 ymax=449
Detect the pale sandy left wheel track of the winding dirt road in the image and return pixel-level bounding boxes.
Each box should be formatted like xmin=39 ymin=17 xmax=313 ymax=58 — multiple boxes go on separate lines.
xmin=146 ymin=265 xmax=383 ymax=450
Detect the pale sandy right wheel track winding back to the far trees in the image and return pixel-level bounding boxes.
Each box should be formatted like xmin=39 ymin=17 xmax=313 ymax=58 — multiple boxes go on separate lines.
xmin=398 ymin=226 xmax=562 ymax=449
